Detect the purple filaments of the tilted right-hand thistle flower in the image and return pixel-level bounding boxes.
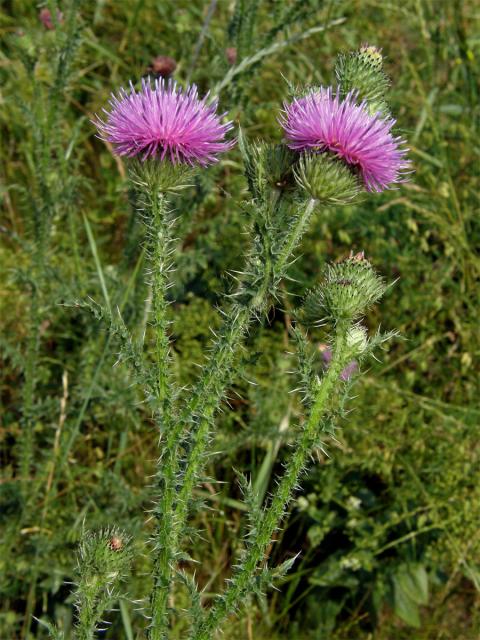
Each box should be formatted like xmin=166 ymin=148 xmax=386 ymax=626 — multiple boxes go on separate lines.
xmin=280 ymin=87 xmax=410 ymax=191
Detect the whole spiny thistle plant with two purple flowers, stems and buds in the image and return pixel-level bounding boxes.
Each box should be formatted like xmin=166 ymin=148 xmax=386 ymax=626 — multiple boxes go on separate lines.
xmin=60 ymin=42 xmax=409 ymax=640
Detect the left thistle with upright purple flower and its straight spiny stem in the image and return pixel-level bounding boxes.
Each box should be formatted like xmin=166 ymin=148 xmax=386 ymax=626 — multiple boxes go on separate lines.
xmin=96 ymin=80 xmax=232 ymax=638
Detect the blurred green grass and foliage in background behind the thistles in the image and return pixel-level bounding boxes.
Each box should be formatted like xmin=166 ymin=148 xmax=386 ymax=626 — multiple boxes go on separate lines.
xmin=0 ymin=0 xmax=480 ymax=640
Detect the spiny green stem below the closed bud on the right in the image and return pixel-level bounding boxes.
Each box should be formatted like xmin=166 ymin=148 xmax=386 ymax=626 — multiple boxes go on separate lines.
xmin=193 ymin=323 xmax=348 ymax=640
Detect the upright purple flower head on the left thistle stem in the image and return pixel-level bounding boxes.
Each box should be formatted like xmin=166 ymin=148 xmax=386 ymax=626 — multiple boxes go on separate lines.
xmin=93 ymin=79 xmax=234 ymax=166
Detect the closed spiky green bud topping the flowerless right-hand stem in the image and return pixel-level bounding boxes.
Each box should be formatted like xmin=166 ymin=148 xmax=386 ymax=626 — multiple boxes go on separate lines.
xmin=300 ymin=254 xmax=386 ymax=324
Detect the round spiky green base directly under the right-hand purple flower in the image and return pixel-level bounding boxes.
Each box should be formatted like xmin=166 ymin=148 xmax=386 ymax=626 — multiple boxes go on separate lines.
xmin=294 ymin=153 xmax=361 ymax=204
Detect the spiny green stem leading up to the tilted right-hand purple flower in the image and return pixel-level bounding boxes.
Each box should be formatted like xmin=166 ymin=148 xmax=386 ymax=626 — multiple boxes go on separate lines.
xmin=150 ymin=201 xmax=314 ymax=640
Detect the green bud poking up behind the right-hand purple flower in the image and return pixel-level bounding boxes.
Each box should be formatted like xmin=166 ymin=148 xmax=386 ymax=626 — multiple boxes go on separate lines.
xmin=335 ymin=45 xmax=390 ymax=115
